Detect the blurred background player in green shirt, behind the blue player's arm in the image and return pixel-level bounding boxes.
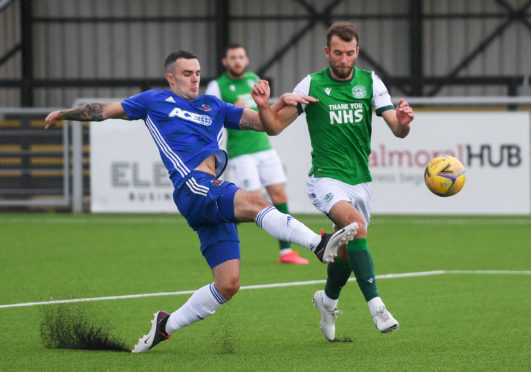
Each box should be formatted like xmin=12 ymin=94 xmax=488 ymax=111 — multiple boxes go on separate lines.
xmin=205 ymin=44 xmax=309 ymax=264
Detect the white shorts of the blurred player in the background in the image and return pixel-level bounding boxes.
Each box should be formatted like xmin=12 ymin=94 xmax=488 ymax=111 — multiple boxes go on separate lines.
xmin=229 ymin=149 xmax=286 ymax=191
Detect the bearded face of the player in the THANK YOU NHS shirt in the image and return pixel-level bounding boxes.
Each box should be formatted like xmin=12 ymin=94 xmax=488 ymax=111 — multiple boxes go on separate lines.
xmin=325 ymin=35 xmax=359 ymax=80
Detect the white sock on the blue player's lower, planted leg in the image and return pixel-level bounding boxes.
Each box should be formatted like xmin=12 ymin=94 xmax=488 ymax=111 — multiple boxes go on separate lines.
xmin=166 ymin=283 xmax=227 ymax=334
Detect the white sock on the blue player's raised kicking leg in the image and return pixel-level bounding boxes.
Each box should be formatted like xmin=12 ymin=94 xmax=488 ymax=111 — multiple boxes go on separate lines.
xmin=256 ymin=205 xmax=321 ymax=252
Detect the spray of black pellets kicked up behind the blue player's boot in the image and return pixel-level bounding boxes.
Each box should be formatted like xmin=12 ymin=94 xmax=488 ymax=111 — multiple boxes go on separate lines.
xmin=41 ymin=305 xmax=131 ymax=352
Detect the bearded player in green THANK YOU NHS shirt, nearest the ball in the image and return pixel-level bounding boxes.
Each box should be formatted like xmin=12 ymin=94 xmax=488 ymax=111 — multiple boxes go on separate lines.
xmin=253 ymin=22 xmax=414 ymax=341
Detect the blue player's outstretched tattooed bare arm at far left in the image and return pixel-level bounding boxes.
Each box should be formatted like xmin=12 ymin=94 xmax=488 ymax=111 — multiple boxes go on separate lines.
xmin=44 ymin=102 xmax=129 ymax=129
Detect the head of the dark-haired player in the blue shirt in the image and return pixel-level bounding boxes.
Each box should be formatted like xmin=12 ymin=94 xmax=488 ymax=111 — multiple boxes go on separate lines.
xmin=166 ymin=58 xmax=201 ymax=101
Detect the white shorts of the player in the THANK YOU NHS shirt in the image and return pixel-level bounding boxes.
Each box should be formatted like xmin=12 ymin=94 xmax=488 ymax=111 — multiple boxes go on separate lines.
xmin=306 ymin=175 xmax=371 ymax=227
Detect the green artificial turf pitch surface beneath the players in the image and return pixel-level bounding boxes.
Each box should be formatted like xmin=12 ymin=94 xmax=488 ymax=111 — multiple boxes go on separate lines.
xmin=0 ymin=214 xmax=531 ymax=371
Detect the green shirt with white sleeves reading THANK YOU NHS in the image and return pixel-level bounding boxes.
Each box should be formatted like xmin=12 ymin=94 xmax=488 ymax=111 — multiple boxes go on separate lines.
xmin=294 ymin=67 xmax=394 ymax=185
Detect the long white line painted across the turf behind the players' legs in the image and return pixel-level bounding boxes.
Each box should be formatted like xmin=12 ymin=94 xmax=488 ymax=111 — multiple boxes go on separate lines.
xmin=0 ymin=270 xmax=531 ymax=309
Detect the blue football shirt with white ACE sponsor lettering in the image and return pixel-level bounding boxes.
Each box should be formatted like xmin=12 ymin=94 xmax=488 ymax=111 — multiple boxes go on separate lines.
xmin=122 ymin=89 xmax=243 ymax=185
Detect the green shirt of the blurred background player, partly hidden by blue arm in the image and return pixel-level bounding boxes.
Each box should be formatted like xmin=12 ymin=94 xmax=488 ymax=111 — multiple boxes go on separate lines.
xmin=205 ymin=72 xmax=272 ymax=158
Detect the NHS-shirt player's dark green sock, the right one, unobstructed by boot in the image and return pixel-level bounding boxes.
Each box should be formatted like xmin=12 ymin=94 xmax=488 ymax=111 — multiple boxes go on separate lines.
xmin=347 ymin=239 xmax=379 ymax=301
